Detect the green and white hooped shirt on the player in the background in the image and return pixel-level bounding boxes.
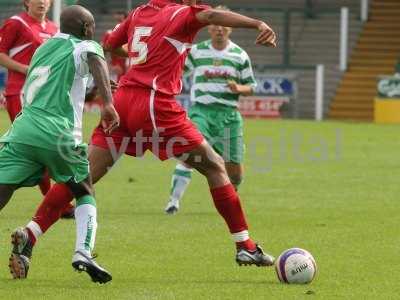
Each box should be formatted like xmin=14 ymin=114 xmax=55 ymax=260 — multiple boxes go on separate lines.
xmin=185 ymin=40 xmax=257 ymax=107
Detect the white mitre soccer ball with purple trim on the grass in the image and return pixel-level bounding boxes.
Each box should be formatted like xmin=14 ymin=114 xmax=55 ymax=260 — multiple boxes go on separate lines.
xmin=275 ymin=248 xmax=317 ymax=284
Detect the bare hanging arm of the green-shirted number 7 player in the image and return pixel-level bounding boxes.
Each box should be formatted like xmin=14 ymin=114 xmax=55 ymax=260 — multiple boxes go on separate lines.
xmin=88 ymin=54 xmax=120 ymax=133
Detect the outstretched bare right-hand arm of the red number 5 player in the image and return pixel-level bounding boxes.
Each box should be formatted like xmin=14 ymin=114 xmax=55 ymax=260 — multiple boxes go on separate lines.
xmin=196 ymin=9 xmax=276 ymax=47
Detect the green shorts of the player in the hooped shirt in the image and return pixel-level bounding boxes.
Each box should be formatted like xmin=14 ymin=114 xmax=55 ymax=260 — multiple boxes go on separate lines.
xmin=189 ymin=103 xmax=244 ymax=164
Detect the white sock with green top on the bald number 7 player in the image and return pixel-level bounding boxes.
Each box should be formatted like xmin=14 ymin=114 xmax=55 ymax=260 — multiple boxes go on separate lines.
xmin=75 ymin=196 xmax=97 ymax=256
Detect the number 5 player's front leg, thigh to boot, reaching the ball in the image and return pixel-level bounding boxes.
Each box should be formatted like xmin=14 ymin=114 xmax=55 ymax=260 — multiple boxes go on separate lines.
xmin=182 ymin=142 xmax=274 ymax=266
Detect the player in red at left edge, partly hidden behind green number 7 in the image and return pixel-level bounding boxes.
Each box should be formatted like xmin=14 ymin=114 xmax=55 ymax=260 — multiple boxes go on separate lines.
xmin=0 ymin=0 xmax=58 ymax=199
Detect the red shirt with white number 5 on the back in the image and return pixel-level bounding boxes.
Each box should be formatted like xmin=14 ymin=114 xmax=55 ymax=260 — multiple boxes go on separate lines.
xmin=106 ymin=0 xmax=209 ymax=95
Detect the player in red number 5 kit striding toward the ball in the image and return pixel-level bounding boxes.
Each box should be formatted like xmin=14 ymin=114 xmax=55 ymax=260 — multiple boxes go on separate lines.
xmin=10 ymin=0 xmax=276 ymax=278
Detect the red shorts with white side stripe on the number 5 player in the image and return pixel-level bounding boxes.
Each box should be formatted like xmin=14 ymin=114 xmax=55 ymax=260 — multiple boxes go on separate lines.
xmin=91 ymin=87 xmax=204 ymax=160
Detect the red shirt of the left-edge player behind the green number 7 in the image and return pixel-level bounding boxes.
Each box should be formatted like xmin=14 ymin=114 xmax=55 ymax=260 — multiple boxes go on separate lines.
xmin=0 ymin=12 xmax=58 ymax=96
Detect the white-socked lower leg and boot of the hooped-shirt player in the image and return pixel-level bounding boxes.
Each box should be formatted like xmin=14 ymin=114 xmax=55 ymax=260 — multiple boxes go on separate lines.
xmin=165 ymin=163 xmax=193 ymax=215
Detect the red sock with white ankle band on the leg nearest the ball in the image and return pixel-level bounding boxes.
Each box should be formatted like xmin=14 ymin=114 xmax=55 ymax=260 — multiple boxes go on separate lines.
xmin=211 ymin=184 xmax=256 ymax=251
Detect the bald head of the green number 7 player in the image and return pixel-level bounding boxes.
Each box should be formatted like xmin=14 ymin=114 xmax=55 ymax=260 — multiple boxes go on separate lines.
xmin=60 ymin=5 xmax=94 ymax=40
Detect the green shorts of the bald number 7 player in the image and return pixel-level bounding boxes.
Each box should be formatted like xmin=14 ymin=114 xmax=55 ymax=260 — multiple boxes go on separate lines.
xmin=0 ymin=143 xmax=89 ymax=187
